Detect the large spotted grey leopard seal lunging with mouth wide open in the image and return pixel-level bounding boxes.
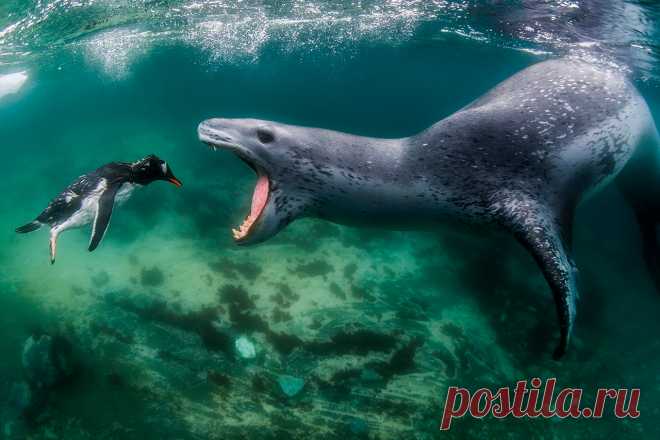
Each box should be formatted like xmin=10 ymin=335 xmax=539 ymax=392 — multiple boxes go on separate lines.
xmin=198 ymin=58 xmax=660 ymax=359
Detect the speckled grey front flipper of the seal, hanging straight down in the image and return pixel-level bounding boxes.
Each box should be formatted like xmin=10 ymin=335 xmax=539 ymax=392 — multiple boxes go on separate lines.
xmin=493 ymin=193 xmax=578 ymax=360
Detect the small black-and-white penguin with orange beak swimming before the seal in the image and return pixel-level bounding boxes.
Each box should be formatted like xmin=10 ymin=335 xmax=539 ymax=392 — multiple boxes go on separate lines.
xmin=16 ymin=154 xmax=181 ymax=264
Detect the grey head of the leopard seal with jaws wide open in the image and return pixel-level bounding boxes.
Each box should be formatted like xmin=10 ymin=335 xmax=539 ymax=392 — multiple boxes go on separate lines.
xmin=197 ymin=118 xmax=309 ymax=244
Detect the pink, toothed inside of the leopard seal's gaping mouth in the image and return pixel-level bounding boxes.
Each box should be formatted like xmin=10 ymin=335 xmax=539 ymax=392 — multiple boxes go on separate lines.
xmin=200 ymin=131 xmax=270 ymax=242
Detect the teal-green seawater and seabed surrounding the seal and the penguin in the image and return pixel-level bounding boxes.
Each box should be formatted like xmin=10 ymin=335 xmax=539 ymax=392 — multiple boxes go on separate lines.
xmin=0 ymin=0 xmax=660 ymax=439
